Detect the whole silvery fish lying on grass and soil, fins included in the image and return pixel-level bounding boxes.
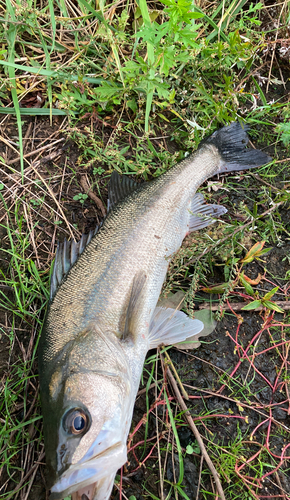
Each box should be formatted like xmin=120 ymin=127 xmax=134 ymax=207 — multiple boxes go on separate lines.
xmin=38 ymin=122 xmax=271 ymax=500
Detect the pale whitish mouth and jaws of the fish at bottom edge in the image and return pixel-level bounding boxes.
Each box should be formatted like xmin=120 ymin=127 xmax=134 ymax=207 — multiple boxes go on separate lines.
xmin=49 ymin=442 xmax=127 ymax=500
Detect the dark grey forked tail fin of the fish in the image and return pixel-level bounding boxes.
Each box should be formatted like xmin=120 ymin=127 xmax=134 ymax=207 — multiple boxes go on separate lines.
xmin=199 ymin=122 xmax=272 ymax=173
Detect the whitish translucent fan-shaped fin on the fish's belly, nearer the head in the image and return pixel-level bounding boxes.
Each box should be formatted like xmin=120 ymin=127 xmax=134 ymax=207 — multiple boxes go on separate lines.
xmin=149 ymin=307 xmax=204 ymax=349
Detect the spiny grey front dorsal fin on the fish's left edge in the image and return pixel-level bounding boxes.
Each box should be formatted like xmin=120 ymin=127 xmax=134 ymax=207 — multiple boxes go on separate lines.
xmin=50 ymin=226 xmax=99 ymax=300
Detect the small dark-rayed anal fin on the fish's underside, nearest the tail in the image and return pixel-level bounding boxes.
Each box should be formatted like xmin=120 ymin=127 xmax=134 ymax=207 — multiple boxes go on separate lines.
xmin=189 ymin=193 xmax=227 ymax=232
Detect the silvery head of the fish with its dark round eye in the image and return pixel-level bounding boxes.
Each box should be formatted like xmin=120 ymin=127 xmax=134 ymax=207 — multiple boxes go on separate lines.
xmin=42 ymin=326 xmax=135 ymax=500
